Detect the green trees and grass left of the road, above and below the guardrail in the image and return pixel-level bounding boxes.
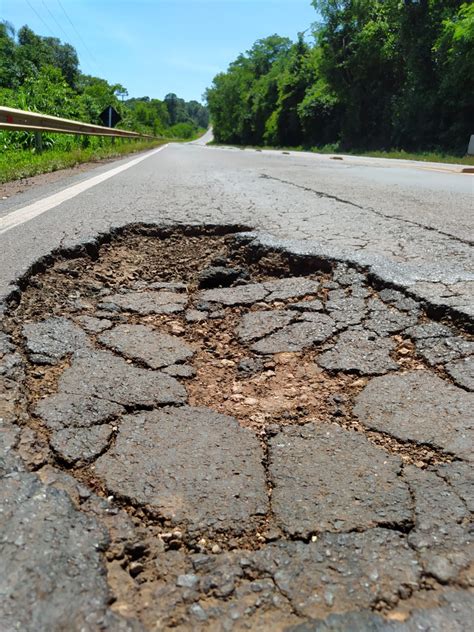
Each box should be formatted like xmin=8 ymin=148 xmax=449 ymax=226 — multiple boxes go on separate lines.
xmin=0 ymin=22 xmax=209 ymax=182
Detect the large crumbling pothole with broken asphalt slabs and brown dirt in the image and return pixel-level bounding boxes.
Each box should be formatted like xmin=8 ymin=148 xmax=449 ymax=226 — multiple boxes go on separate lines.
xmin=0 ymin=228 xmax=474 ymax=630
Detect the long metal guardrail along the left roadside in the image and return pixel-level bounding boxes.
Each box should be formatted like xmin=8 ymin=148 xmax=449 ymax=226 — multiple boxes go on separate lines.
xmin=0 ymin=106 xmax=154 ymax=138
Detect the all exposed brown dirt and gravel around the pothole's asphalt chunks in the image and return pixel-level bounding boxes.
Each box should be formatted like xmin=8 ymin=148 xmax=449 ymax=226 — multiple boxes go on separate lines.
xmin=1 ymin=228 xmax=472 ymax=630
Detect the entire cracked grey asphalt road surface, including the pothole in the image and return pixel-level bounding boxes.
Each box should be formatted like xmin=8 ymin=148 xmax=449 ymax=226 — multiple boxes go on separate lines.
xmin=0 ymin=143 xmax=474 ymax=632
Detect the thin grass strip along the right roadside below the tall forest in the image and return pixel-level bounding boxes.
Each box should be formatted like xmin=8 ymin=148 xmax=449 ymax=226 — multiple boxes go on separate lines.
xmin=209 ymin=141 xmax=474 ymax=166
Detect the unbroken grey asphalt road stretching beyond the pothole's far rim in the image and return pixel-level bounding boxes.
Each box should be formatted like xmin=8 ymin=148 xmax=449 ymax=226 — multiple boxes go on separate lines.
xmin=0 ymin=137 xmax=474 ymax=316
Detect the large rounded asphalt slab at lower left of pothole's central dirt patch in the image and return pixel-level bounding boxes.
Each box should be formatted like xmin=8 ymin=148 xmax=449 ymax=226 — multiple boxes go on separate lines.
xmin=95 ymin=406 xmax=268 ymax=534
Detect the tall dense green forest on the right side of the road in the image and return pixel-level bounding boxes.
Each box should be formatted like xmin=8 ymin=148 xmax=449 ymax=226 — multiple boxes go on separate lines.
xmin=207 ymin=0 xmax=474 ymax=153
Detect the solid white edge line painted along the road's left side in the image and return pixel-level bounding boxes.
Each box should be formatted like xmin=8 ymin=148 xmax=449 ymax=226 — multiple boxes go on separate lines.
xmin=0 ymin=145 xmax=168 ymax=235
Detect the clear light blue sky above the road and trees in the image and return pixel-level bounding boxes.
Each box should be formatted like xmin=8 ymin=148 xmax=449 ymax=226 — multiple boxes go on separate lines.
xmin=0 ymin=0 xmax=317 ymax=100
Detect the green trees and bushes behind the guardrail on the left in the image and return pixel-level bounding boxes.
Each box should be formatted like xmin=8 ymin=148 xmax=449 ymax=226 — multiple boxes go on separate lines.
xmin=0 ymin=22 xmax=209 ymax=138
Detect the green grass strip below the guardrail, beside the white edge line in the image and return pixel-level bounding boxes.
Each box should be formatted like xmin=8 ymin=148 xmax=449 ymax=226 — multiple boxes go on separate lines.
xmin=0 ymin=139 xmax=168 ymax=184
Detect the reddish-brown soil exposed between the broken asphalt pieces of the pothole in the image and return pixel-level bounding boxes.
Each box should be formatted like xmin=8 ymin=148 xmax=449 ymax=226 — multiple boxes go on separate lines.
xmin=5 ymin=230 xmax=470 ymax=629
